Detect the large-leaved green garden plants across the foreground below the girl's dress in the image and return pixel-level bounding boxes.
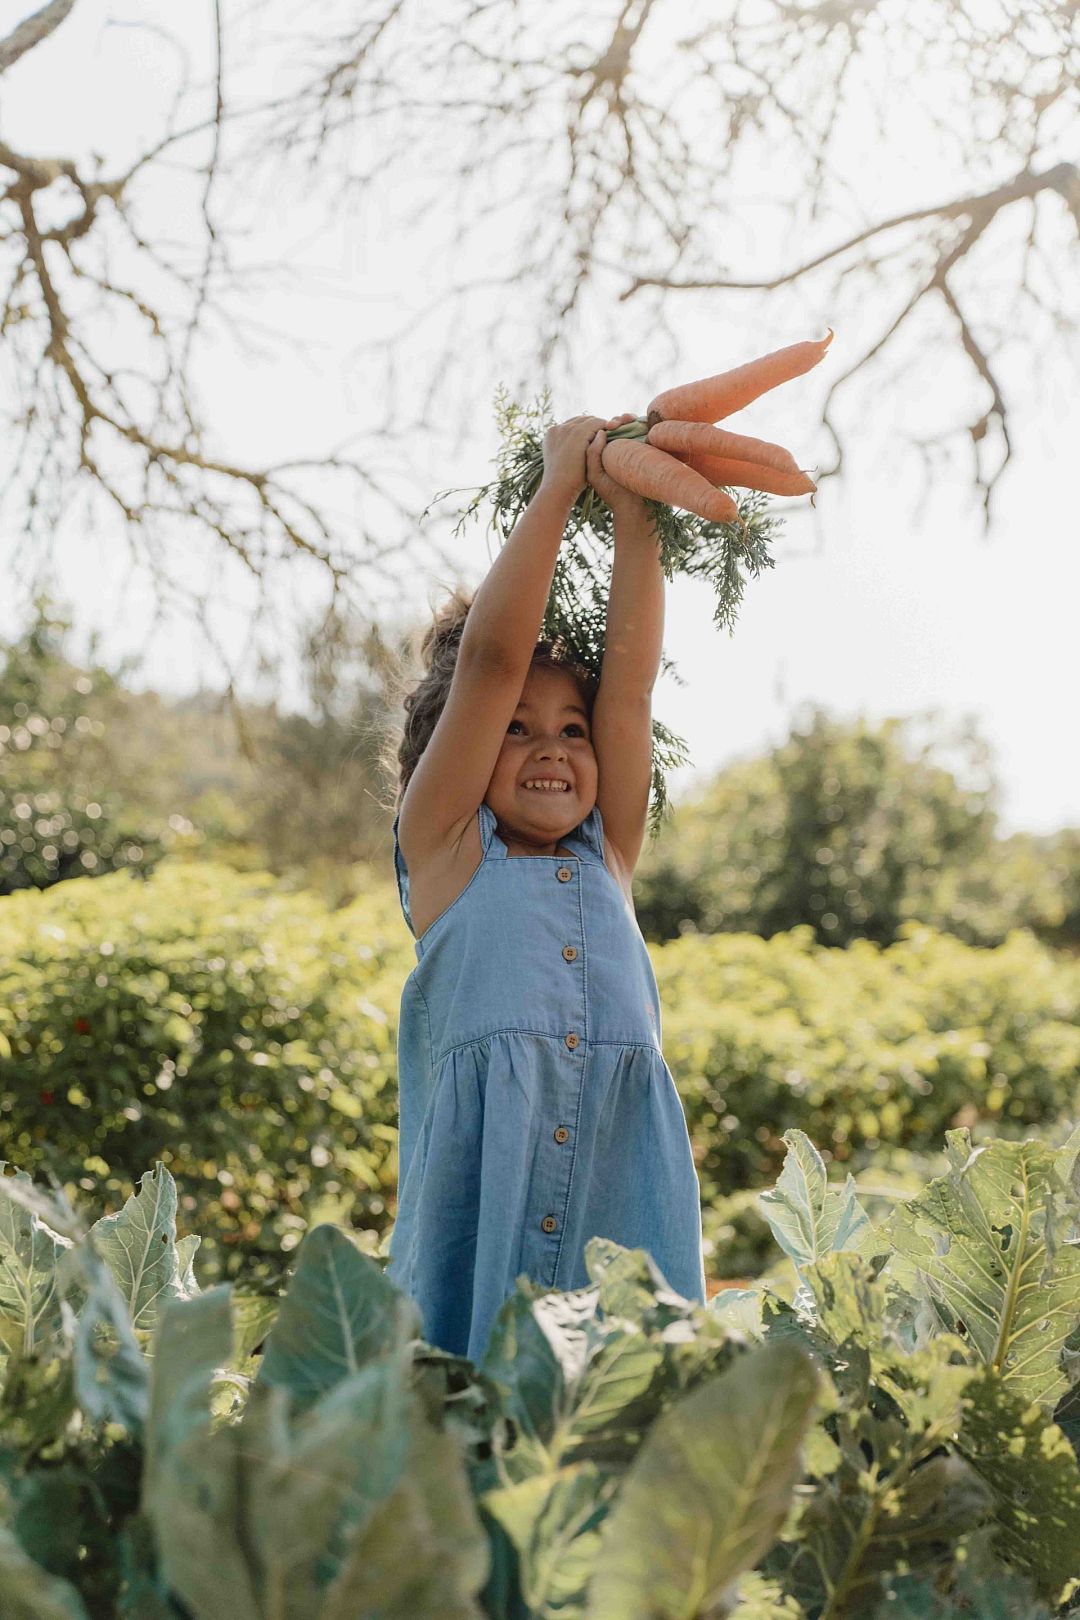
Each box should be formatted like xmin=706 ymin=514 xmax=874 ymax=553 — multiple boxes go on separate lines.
xmin=0 ymin=1131 xmax=1080 ymax=1620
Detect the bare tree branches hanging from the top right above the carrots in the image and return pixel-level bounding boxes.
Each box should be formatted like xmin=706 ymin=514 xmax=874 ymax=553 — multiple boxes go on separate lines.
xmin=249 ymin=0 xmax=1080 ymax=522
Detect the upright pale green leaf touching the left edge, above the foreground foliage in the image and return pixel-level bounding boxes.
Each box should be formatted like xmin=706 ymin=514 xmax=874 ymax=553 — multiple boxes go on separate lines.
xmin=0 ymin=1160 xmax=70 ymax=1364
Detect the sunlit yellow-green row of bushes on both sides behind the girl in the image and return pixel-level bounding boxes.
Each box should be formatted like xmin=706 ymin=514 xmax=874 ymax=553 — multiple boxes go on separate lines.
xmin=0 ymin=859 xmax=1080 ymax=1278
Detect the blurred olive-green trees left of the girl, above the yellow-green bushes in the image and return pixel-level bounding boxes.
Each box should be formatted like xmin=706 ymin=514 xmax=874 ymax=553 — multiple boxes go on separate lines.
xmin=0 ymin=599 xmax=401 ymax=899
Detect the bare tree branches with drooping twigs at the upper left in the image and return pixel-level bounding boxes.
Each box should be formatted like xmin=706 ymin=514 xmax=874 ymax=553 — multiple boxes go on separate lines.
xmin=0 ymin=0 xmax=459 ymax=667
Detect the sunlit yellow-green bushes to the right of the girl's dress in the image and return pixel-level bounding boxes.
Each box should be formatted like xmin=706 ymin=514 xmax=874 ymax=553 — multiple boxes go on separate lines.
xmin=653 ymin=925 xmax=1080 ymax=1270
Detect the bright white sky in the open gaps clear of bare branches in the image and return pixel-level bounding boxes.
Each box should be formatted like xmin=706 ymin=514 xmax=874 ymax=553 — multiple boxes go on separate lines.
xmin=0 ymin=0 xmax=1080 ymax=831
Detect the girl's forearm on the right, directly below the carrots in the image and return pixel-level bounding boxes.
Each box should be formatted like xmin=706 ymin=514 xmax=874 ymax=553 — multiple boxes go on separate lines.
xmin=602 ymin=502 xmax=664 ymax=697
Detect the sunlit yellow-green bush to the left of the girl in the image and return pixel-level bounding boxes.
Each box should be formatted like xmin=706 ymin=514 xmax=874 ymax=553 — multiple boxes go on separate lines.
xmin=0 ymin=860 xmax=411 ymax=1273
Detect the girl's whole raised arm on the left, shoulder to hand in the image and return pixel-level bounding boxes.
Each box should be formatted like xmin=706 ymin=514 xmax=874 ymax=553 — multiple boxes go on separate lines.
xmin=398 ymin=416 xmax=604 ymax=863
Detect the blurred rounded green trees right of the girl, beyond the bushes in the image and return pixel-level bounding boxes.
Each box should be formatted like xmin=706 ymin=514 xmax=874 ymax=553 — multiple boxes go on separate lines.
xmin=635 ymin=710 xmax=1080 ymax=944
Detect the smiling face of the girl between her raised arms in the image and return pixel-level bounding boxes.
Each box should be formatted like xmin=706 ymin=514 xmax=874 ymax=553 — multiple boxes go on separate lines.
xmin=484 ymin=664 xmax=596 ymax=844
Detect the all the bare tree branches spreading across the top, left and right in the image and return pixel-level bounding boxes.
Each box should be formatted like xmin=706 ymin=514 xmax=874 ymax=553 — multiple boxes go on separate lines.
xmin=0 ymin=0 xmax=1080 ymax=686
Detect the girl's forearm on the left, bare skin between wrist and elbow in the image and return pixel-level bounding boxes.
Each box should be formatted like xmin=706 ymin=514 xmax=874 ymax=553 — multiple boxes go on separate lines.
xmin=461 ymin=483 xmax=575 ymax=679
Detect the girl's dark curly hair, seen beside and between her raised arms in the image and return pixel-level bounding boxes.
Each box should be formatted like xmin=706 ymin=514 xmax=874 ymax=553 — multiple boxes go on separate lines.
xmin=382 ymin=588 xmax=599 ymax=812
